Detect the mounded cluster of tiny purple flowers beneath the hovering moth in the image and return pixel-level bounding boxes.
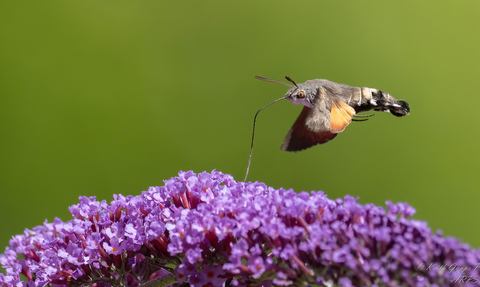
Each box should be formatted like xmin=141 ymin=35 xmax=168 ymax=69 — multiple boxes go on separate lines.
xmin=0 ymin=170 xmax=480 ymax=287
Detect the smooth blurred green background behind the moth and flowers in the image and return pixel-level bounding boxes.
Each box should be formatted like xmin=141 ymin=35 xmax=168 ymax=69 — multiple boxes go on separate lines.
xmin=0 ymin=0 xmax=480 ymax=258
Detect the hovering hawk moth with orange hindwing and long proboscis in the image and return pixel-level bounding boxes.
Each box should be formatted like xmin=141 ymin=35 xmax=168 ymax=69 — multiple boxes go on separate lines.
xmin=245 ymin=76 xmax=410 ymax=180
